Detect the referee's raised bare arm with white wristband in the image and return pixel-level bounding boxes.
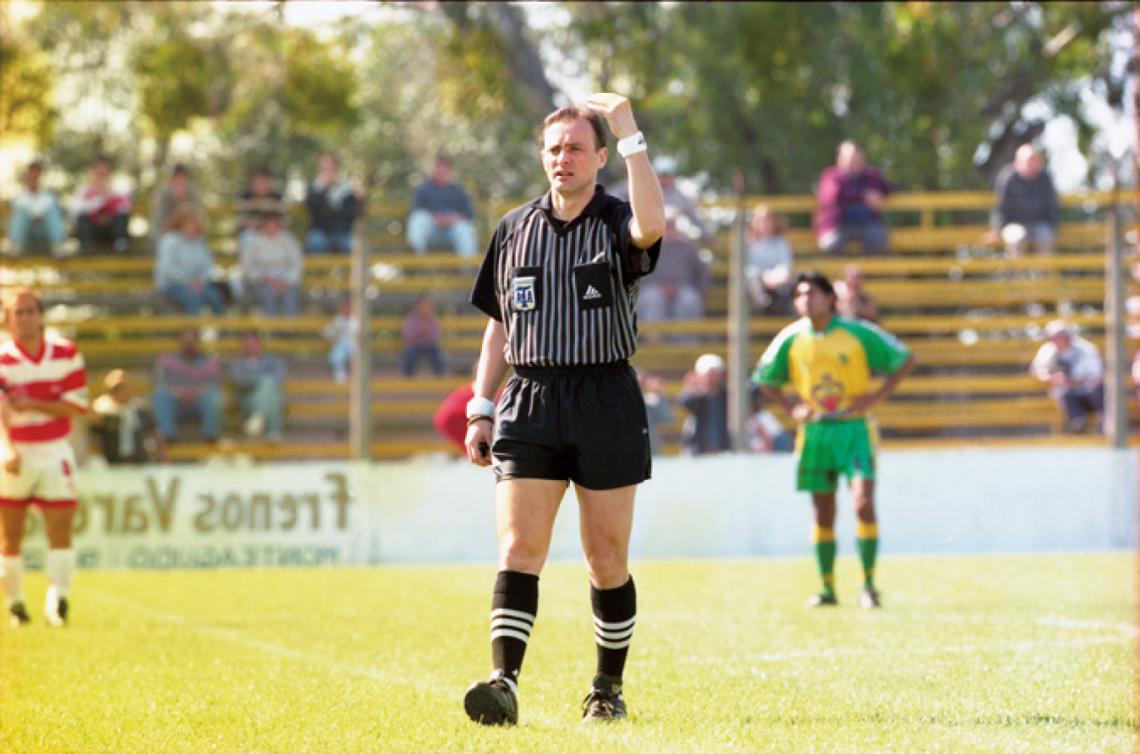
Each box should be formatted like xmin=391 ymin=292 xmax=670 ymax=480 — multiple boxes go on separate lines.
xmin=586 ymin=91 xmax=665 ymax=249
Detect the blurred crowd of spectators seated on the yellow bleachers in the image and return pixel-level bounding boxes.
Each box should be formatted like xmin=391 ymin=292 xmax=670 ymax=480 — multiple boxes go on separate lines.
xmin=3 ymin=140 xmax=1121 ymax=462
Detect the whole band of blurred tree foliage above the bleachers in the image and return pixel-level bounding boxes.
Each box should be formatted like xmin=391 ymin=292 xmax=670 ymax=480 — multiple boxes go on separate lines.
xmin=0 ymin=2 xmax=1129 ymax=205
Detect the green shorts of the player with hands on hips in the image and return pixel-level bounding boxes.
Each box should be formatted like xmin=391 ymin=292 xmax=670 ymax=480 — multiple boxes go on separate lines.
xmin=796 ymin=419 xmax=879 ymax=493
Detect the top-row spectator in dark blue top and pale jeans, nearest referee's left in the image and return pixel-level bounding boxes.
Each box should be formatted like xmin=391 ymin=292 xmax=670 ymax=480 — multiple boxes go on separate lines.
xmin=408 ymin=156 xmax=479 ymax=257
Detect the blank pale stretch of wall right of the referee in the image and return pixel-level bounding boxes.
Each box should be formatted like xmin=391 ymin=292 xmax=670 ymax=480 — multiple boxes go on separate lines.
xmin=624 ymin=448 xmax=1138 ymax=557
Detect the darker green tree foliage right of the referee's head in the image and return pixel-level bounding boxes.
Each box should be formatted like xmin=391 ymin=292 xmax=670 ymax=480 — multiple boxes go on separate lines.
xmin=562 ymin=2 xmax=1124 ymax=193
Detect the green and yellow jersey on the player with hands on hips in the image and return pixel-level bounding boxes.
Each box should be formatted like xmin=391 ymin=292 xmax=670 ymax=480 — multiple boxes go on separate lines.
xmin=752 ymin=316 xmax=911 ymax=414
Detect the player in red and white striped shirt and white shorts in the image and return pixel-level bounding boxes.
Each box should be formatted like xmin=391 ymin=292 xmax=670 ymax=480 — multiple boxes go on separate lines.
xmin=0 ymin=289 xmax=87 ymax=625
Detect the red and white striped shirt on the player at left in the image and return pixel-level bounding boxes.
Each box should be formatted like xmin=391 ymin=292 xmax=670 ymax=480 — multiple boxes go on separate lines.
xmin=0 ymin=333 xmax=87 ymax=443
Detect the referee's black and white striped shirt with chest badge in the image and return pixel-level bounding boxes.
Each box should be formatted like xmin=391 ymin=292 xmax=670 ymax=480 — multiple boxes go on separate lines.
xmin=471 ymin=186 xmax=661 ymax=366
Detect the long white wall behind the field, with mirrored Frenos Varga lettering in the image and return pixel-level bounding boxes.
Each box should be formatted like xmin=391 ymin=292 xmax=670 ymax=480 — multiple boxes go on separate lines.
xmin=25 ymin=448 xmax=1138 ymax=569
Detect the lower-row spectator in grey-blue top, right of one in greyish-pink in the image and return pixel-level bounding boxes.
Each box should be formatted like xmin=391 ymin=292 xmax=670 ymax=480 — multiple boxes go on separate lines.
xmin=228 ymin=331 xmax=285 ymax=444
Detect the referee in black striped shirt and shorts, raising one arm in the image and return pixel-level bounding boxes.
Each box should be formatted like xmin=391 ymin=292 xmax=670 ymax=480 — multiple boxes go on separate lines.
xmin=464 ymin=94 xmax=665 ymax=724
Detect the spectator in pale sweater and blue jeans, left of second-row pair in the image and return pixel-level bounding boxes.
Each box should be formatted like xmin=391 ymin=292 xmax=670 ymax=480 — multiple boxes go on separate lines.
xmin=154 ymin=206 xmax=226 ymax=315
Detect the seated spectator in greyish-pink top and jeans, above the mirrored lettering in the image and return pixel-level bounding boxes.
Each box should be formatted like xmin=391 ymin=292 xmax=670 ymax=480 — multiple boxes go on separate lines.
xmin=153 ymin=327 xmax=221 ymax=443
